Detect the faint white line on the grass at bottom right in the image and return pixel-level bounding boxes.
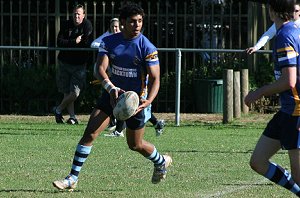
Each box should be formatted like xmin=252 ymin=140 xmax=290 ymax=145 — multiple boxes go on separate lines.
xmin=197 ymin=178 xmax=269 ymax=198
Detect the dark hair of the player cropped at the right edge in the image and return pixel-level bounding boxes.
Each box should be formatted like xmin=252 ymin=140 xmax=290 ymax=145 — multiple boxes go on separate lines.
xmin=268 ymin=0 xmax=296 ymax=21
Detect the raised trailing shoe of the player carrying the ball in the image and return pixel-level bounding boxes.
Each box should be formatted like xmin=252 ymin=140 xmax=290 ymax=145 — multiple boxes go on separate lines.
xmin=152 ymin=155 xmax=172 ymax=184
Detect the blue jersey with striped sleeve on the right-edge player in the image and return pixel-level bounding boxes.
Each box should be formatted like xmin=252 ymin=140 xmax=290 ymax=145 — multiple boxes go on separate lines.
xmin=273 ymin=22 xmax=300 ymax=116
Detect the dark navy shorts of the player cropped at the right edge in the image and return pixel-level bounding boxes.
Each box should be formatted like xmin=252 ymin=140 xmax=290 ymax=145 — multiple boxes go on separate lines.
xmin=263 ymin=111 xmax=300 ymax=150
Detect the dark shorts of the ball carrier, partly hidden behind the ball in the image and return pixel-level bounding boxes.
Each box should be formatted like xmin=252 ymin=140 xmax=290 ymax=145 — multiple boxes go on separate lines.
xmin=95 ymin=90 xmax=151 ymax=130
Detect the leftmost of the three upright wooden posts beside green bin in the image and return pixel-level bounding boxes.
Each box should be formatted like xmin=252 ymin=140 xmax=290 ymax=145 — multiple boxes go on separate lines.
xmin=223 ymin=69 xmax=233 ymax=124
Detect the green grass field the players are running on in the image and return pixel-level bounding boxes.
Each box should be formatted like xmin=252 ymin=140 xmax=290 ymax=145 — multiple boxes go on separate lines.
xmin=0 ymin=115 xmax=293 ymax=198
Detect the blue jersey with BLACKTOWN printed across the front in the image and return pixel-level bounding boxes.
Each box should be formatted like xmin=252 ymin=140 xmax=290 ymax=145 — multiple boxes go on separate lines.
xmin=99 ymin=32 xmax=159 ymax=97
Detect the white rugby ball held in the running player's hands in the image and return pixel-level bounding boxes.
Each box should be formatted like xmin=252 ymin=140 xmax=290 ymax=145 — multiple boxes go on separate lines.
xmin=113 ymin=91 xmax=140 ymax=121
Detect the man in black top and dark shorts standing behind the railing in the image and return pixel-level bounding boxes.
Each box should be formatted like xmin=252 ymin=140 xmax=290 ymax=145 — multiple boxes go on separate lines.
xmin=54 ymin=4 xmax=93 ymax=124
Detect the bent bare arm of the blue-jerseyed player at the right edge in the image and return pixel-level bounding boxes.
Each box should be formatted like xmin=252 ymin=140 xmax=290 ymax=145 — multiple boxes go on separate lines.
xmin=245 ymin=65 xmax=297 ymax=106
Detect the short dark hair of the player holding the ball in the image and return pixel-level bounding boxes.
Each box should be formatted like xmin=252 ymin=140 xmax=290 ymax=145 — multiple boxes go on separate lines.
xmin=119 ymin=2 xmax=145 ymax=19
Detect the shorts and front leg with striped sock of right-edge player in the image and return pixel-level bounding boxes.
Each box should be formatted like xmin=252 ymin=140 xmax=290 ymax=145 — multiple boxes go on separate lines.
xmin=250 ymin=112 xmax=300 ymax=195
